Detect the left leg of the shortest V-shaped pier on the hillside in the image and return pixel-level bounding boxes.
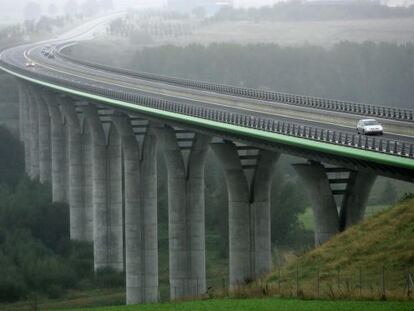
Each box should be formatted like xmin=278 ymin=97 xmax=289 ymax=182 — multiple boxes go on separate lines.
xmin=293 ymin=162 xmax=339 ymax=246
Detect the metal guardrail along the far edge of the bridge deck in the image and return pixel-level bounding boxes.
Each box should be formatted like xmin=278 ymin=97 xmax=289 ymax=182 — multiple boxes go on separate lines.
xmin=56 ymin=45 xmax=414 ymax=122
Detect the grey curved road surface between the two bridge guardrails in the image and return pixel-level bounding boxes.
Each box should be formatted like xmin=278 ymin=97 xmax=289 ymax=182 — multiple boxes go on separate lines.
xmin=0 ymin=16 xmax=414 ymax=182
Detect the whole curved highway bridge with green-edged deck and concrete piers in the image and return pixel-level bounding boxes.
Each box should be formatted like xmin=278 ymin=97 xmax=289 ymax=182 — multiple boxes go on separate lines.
xmin=0 ymin=18 xmax=414 ymax=304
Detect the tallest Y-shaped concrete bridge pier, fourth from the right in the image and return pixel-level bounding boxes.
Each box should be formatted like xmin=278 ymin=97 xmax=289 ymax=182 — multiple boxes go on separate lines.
xmin=112 ymin=115 xmax=159 ymax=304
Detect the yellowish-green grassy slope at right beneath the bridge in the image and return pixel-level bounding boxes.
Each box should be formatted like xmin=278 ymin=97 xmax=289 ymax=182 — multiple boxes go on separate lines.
xmin=267 ymin=198 xmax=414 ymax=297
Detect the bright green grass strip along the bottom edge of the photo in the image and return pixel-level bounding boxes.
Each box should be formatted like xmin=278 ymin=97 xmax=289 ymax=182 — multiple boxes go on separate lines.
xmin=51 ymin=298 xmax=414 ymax=311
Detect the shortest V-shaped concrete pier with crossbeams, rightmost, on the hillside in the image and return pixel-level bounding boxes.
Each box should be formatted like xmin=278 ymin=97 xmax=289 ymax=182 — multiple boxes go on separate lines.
xmin=294 ymin=162 xmax=376 ymax=246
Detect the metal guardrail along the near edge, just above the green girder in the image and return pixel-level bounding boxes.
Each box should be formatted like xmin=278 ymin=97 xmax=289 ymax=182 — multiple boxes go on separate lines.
xmin=0 ymin=60 xmax=414 ymax=159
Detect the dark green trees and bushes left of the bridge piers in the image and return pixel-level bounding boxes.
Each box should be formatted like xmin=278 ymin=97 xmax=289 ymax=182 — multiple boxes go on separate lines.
xmin=0 ymin=127 xmax=124 ymax=303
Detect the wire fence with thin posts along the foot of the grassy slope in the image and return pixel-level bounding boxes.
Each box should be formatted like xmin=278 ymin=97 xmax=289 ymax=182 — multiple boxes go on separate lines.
xmin=147 ymin=265 xmax=414 ymax=302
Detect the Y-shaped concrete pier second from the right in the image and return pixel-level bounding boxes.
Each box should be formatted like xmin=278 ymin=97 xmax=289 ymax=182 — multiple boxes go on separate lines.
xmin=212 ymin=142 xmax=279 ymax=286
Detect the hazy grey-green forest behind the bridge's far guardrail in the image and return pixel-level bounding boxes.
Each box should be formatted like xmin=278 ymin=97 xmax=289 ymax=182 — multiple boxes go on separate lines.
xmin=123 ymin=42 xmax=414 ymax=108
